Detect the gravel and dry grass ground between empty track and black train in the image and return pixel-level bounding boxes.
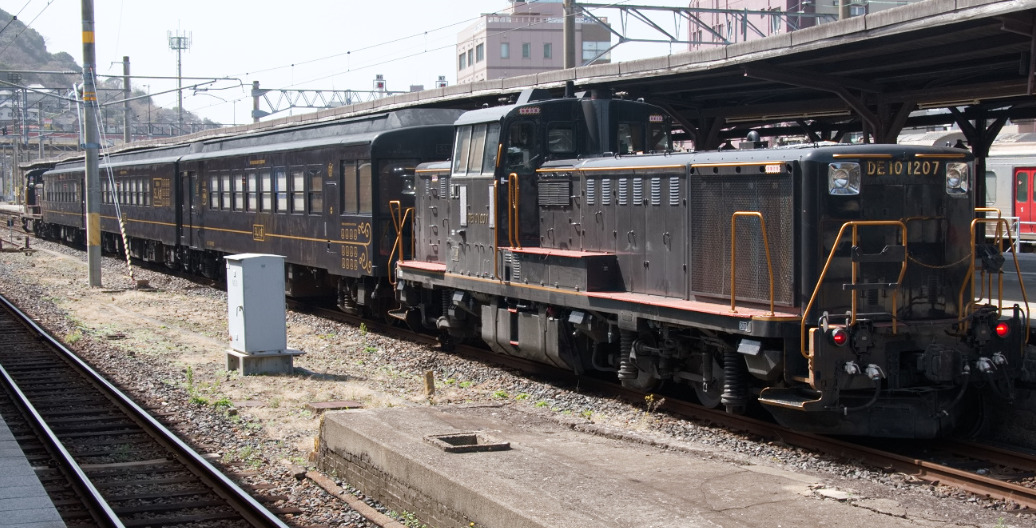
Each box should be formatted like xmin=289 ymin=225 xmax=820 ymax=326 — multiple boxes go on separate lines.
xmin=0 ymin=236 xmax=1036 ymax=527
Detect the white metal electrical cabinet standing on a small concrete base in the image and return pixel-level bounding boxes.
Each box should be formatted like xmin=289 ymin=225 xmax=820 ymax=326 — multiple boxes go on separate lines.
xmin=225 ymin=254 xmax=288 ymax=354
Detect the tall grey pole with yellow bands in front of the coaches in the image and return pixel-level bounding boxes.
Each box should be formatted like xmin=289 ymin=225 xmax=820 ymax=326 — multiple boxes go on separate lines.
xmin=82 ymin=0 xmax=102 ymax=288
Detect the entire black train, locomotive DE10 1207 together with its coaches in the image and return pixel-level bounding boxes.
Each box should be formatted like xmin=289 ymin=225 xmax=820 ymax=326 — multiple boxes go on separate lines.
xmin=37 ymin=90 xmax=1036 ymax=438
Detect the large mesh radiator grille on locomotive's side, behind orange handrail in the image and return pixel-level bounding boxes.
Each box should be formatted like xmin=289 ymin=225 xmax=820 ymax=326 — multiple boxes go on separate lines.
xmin=688 ymin=173 xmax=796 ymax=305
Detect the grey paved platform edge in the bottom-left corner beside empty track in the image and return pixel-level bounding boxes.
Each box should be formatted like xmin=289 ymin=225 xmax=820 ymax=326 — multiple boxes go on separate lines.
xmin=0 ymin=416 xmax=65 ymax=528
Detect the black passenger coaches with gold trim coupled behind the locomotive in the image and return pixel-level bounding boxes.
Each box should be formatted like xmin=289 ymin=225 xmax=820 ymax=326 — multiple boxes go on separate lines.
xmin=37 ymin=110 xmax=461 ymax=310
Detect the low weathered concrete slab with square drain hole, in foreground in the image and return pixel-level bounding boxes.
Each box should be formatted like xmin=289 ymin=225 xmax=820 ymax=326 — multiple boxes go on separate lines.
xmin=318 ymin=406 xmax=969 ymax=528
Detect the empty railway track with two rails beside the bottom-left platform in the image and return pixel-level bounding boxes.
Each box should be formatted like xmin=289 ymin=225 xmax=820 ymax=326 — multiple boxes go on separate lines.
xmin=0 ymin=289 xmax=286 ymax=527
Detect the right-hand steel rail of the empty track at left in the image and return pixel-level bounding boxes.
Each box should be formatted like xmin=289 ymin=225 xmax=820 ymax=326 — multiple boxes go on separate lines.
xmin=0 ymin=295 xmax=288 ymax=528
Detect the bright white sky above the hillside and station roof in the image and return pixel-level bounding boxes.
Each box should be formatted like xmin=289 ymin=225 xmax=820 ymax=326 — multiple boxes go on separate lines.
xmin=10 ymin=0 xmax=688 ymax=123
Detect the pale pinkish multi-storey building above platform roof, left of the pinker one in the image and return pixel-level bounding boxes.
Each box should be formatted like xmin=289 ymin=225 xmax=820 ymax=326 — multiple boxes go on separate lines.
xmin=457 ymin=0 xmax=611 ymax=83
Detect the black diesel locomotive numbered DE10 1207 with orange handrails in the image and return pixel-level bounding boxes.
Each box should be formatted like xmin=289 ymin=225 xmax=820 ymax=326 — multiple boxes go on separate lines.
xmin=397 ymin=89 xmax=1036 ymax=438
